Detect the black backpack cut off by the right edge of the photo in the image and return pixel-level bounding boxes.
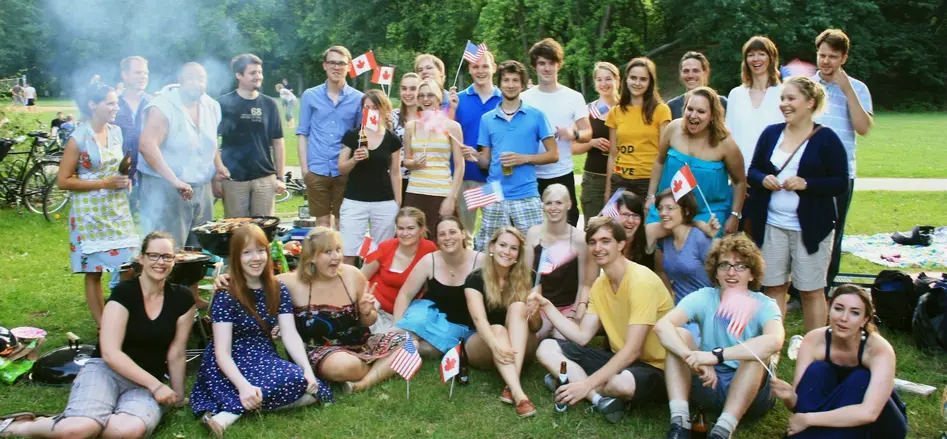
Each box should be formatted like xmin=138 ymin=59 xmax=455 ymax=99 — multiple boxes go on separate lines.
xmin=912 ymin=274 xmax=947 ymax=353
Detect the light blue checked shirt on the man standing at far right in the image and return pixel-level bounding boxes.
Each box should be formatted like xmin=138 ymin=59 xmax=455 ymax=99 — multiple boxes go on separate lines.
xmin=810 ymin=72 xmax=874 ymax=179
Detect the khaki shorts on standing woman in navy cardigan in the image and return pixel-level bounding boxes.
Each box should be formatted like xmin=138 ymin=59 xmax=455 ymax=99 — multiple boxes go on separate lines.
xmin=762 ymin=224 xmax=835 ymax=291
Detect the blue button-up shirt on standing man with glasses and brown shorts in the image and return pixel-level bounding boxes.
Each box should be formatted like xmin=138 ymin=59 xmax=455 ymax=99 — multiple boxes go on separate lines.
xmin=296 ymin=84 xmax=363 ymax=177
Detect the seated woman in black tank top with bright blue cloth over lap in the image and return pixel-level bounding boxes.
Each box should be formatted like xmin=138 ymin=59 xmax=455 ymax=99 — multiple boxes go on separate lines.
xmin=393 ymin=216 xmax=483 ymax=357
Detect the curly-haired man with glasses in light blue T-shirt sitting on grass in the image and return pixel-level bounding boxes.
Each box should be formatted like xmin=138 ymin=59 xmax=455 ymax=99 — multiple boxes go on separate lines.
xmin=654 ymin=233 xmax=785 ymax=439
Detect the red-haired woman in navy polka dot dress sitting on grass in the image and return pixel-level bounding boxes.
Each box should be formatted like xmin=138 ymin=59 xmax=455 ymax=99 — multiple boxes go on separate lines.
xmin=191 ymin=224 xmax=332 ymax=437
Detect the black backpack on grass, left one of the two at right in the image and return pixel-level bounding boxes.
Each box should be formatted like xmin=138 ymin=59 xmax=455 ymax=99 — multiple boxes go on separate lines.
xmin=871 ymin=270 xmax=920 ymax=332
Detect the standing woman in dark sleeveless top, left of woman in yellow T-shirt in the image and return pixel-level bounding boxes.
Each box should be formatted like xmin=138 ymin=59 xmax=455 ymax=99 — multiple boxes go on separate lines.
xmin=572 ymin=61 xmax=621 ymax=222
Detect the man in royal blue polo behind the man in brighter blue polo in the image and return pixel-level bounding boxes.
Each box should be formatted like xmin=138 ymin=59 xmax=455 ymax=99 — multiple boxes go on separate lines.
xmin=449 ymin=52 xmax=503 ymax=232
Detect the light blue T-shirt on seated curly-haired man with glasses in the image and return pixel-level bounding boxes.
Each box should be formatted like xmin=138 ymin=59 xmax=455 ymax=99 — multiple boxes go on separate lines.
xmin=677 ymin=287 xmax=782 ymax=369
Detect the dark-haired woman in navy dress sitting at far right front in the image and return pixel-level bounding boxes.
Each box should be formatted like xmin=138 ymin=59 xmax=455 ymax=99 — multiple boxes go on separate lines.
xmin=772 ymin=285 xmax=908 ymax=439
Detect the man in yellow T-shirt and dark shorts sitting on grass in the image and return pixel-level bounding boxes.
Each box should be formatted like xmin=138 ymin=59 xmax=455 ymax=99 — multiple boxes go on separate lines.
xmin=527 ymin=217 xmax=674 ymax=422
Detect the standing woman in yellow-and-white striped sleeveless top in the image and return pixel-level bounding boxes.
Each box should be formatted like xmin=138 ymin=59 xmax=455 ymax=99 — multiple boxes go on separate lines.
xmin=404 ymin=79 xmax=464 ymax=235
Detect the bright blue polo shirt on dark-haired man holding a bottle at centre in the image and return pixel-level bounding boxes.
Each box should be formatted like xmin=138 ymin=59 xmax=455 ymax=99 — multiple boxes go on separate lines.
xmin=477 ymin=103 xmax=552 ymax=200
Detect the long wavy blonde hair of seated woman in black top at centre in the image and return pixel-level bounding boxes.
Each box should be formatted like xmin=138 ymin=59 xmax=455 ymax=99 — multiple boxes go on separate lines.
xmin=483 ymin=226 xmax=530 ymax=309
